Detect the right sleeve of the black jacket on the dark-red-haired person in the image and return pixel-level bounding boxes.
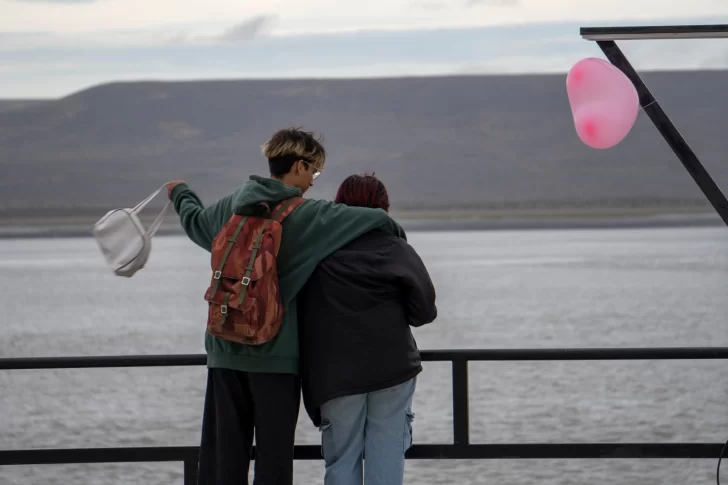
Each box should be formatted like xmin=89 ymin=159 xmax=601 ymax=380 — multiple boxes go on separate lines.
xmin=392 ymin=241 xmax=437 ymax=327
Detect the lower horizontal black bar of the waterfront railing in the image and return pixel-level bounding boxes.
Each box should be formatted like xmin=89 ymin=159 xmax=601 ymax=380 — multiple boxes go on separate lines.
xmin=0 ymin=443 xmax=723 ymax=466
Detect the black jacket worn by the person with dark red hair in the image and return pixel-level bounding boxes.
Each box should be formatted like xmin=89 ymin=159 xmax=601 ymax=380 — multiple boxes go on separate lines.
xmin=297 ymin=230 xmax=437 ymax=426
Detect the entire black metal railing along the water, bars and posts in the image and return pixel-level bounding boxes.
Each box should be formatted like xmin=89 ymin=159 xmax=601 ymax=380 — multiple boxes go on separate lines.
xmin=0 ymin=347 xmax=728 ymax=485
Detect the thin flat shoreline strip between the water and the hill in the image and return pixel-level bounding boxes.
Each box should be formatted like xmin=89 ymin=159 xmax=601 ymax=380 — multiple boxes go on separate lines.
xmin=0 ymin=213 xmax=723 ymax=239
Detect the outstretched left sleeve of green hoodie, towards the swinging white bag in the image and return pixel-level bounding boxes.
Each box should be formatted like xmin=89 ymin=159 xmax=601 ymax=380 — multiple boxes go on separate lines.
xmin=171 ymin=184 xmax=233 ymax=251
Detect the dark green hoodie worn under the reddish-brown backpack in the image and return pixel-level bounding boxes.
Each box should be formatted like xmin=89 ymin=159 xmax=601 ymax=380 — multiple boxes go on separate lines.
xmin=171 ymin=176 xmax=406 ymax=374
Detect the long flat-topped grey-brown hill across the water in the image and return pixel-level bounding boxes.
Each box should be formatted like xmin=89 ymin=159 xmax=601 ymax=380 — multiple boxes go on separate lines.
xmin=0 ymin=71 xmax=728 ymax=217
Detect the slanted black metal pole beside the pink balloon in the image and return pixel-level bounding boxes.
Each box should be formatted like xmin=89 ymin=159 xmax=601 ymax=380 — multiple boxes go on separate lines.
xmin=597 ymin=40 xmax=728 ymax=225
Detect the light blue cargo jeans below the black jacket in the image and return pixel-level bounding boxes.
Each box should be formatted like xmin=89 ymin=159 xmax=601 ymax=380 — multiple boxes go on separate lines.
xmin=319 ymin=378 xmax=417 ymax=485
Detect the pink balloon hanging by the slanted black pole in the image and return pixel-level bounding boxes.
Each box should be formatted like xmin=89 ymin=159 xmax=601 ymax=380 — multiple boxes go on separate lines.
xmin=566 ymin=57 xmax=640 ymax=149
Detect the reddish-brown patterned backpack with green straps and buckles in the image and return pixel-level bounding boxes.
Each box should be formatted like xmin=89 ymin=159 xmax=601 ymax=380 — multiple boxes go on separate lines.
xmin=205 ymin=197 xmax=303 ymax=345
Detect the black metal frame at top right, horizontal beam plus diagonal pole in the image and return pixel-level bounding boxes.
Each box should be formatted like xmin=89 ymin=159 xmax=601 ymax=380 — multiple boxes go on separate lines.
xmin=580 ymin=25 xmax=728 ymax=225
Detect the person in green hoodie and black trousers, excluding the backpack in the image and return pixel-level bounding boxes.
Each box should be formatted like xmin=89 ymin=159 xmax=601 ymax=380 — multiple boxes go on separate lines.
xmin=167 ymin=128 xmax=406 ymax=485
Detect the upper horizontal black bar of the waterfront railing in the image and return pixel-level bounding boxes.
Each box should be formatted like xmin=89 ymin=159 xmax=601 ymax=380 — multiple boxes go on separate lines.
xmin=0 ymin=347 xmax=728 ymax=370
